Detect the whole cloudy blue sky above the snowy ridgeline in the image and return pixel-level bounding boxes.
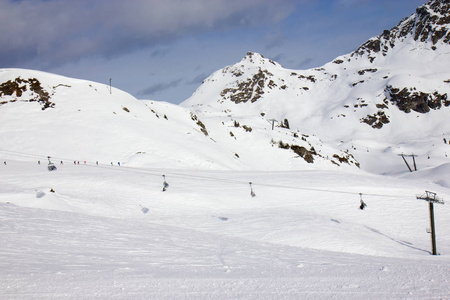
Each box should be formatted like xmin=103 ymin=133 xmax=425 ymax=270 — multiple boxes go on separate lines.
xmin=0 ymin=0 xmax=427 ymax=104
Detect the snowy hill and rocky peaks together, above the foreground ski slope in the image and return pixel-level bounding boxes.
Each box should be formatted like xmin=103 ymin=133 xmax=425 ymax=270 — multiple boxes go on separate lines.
xmin=0 ymin=1 xmax=450 ymax=173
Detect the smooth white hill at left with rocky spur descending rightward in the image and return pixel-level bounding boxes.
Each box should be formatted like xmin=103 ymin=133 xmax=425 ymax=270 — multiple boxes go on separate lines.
xmin=0 ymin=69 xmax=356 ymax=170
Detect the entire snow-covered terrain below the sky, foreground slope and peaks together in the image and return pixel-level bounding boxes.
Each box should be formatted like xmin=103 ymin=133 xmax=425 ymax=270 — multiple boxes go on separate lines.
xmin=0 ymin=1 xmax=450 ymax=300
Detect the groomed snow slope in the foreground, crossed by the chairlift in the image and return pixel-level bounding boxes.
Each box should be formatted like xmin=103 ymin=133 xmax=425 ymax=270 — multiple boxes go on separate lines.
xmin=0 ymin=160 xmax=450 ymax=299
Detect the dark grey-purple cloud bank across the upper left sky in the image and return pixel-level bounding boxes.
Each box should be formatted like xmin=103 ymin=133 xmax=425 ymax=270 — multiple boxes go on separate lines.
xmin=0 ymin=0 xmax=298 ymax=66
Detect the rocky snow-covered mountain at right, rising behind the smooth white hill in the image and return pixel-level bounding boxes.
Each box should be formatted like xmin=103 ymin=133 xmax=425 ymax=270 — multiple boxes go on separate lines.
xmin=182 ymin=1 xmax=450 ymax=172
